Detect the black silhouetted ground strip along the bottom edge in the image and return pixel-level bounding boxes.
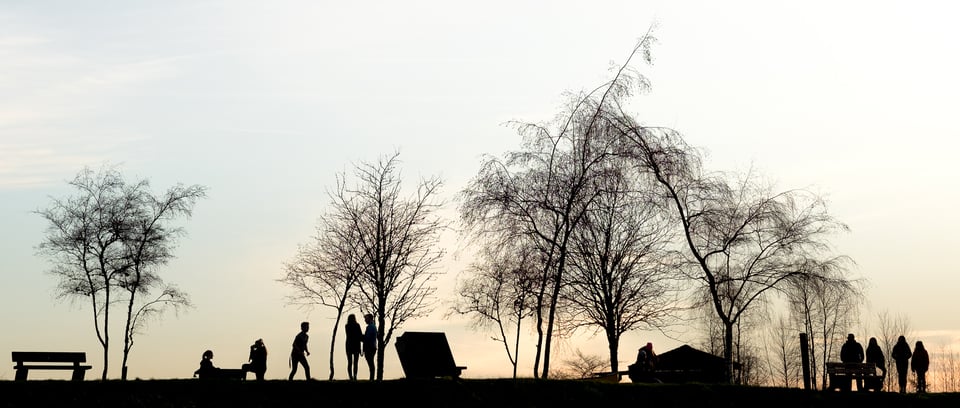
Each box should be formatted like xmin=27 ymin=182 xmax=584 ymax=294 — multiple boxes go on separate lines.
xmin=0 ymin=379 xmax=960 ymax=408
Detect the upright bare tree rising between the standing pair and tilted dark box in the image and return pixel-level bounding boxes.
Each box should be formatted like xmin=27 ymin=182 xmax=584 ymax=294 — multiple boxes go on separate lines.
xmin=331 ymin=152 xmax=447 ymax=380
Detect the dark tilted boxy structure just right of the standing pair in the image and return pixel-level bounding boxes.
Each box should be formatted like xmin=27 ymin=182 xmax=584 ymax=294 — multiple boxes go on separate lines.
xmin=395 ymin=332 xmax=467 ymax=378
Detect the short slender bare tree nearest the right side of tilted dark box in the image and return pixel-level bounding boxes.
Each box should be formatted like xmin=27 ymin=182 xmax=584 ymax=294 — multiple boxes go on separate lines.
xmin=451 ymin=242 xmax=539 ymax=378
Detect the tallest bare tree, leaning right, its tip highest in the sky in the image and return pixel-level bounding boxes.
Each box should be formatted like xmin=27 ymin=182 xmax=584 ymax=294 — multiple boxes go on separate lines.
xmin=460 ymin=29 xmax=654 ymax=378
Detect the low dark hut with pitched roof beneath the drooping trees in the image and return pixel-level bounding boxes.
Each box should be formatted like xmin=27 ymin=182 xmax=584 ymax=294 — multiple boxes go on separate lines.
xmin=630 ymin=344 xmax=740 ymax=383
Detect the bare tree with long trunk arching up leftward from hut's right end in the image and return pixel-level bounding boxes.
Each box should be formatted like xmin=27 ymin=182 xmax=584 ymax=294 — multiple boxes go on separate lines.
xmin=621 ymin=130 xmax=848 ymax=381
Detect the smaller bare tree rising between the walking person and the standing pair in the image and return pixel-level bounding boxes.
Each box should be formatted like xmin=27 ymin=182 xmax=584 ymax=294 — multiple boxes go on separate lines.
xmin=280 ymin=214 xmax=365 ymax=380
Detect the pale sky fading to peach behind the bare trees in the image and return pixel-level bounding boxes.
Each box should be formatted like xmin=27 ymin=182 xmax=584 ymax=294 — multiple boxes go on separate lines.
xmin=0 ymin=0 xmax=960 ymax=380
